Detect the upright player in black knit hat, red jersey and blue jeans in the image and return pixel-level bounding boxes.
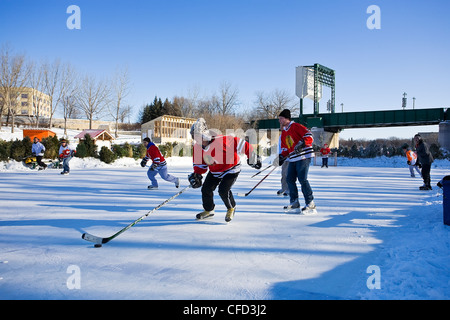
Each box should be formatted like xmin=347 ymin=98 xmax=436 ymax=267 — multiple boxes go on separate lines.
xmin=278 ymin=109 xmax=316 ymax=214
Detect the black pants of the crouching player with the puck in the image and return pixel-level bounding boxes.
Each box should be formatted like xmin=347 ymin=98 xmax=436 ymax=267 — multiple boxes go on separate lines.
xmin=202 ymin=172 xmax=239 ymax=211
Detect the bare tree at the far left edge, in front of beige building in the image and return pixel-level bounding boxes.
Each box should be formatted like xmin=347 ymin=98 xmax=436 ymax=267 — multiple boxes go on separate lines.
xmin=0 ymin=45 xmax=30 ymax=133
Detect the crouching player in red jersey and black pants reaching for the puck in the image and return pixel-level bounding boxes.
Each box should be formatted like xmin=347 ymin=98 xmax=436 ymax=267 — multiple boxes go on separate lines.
xmin=188 ymin=118 xmax=261 ymax=222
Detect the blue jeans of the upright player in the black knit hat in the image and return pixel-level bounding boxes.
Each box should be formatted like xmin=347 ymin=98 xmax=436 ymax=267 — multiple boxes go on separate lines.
xmin=286 ymin=158 xmax=314 ymax=205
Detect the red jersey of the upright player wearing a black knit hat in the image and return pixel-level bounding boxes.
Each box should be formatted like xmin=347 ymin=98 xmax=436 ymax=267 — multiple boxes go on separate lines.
xmin=281 ymin=121 xmax=314 ymax=162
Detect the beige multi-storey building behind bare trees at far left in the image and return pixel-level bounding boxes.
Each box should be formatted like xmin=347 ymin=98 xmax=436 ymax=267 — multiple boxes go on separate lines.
xmin=0 ymin=87 xmax=52 ymax=118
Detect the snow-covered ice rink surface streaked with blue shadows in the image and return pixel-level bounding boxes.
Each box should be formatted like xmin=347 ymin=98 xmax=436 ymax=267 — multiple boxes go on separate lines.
xmin=0 ymin=151 xmax=450 ymax=300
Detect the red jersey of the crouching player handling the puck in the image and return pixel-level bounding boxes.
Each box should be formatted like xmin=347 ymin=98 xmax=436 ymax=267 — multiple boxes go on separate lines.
xmin=193 ymin=136 xmax=253 ymax=178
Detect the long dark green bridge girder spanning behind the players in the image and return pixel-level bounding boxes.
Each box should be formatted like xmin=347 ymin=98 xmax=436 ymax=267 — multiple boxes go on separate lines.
xmin=258 ymin=108 xmax=450 ymax=133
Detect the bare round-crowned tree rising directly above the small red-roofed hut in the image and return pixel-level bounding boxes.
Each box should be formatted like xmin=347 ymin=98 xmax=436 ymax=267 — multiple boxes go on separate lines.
xmin=77 ymin=76 xmax=110 ymax=129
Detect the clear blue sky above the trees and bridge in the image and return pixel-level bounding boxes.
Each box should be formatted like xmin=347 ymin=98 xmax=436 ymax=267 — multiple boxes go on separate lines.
xmin=0 ymin=0 xmax=450 ymax=138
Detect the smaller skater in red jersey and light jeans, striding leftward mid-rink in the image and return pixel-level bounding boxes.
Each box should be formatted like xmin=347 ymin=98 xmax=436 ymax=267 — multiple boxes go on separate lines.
xmin=141 ymin=137 xmax=180 ymax=190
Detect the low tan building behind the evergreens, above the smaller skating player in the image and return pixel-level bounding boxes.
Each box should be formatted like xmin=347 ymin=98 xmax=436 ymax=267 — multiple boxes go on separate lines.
xmin=141 ymin=115 xmax=197 ymax=144
